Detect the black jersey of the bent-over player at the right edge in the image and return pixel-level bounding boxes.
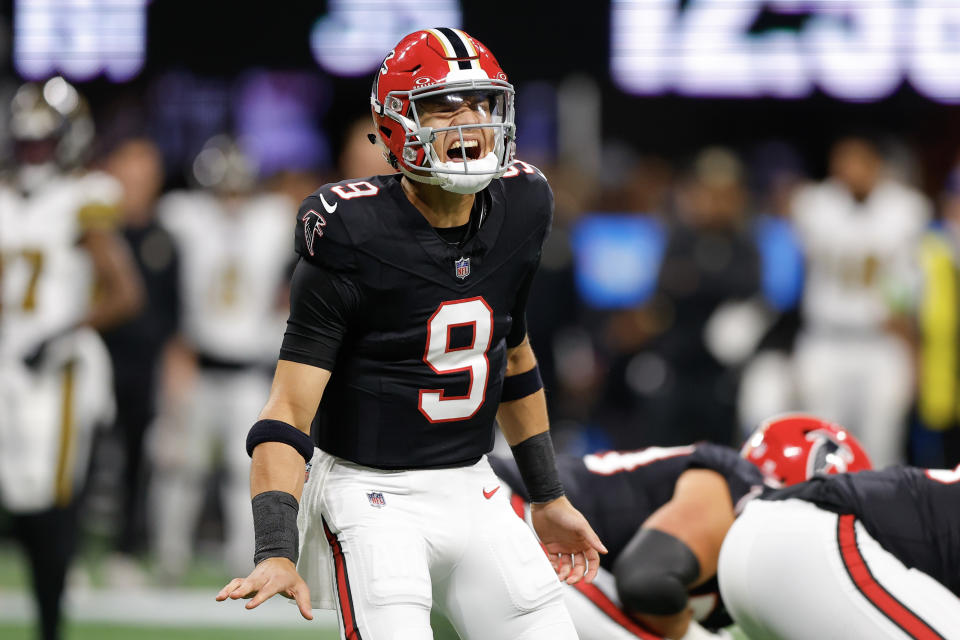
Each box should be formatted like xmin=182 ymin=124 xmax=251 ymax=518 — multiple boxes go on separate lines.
xmin=764 ymin=467 xmax=960 ymax=596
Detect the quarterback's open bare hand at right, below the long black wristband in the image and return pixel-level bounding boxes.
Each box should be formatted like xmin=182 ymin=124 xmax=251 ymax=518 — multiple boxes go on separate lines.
xmin=530 ymin=496 xmax=607 ymax=584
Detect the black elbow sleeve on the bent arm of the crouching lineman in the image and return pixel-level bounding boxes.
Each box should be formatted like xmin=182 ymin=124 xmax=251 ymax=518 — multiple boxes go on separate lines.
xmin=613 ymin=529 xmax=700 ymax=615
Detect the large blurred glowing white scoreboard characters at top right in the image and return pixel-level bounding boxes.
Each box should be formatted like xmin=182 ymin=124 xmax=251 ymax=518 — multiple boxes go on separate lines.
xmin=610 ymin=0 xmax=960 ymax=103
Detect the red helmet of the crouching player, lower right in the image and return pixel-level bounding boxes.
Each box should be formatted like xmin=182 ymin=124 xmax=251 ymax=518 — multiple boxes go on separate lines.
xmin=740 ymin=413 xmax=873 ymax=486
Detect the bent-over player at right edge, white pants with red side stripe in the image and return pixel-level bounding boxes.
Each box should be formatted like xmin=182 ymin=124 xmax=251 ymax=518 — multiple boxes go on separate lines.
xmin=718 ymin=418 xmax=960 ymax=640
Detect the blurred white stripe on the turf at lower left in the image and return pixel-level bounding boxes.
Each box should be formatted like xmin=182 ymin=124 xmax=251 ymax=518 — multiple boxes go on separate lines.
xmin=0 ymin=588 xmax=337 ymax=629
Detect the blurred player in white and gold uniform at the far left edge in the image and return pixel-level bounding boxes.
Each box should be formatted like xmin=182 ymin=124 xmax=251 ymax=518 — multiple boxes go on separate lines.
xmin=0 ymin=78 xmax=142 ymax=639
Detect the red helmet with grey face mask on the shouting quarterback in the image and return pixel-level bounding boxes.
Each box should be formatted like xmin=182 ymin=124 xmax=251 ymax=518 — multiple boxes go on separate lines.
xmin=370 ymin=27 xmax=516 ymax=193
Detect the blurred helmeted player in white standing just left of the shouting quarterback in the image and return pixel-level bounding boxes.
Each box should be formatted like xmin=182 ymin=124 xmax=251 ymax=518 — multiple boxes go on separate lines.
xmin=154 ymin=136 xmax=295 ymax=580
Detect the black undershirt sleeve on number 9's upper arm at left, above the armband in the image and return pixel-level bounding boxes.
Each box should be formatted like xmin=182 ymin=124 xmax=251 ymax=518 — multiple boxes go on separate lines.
xmin=280 ymin=260 xmax=361 ymax=370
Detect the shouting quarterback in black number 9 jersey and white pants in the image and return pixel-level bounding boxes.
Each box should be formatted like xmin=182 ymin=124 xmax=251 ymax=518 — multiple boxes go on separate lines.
xmin=217 ymin=28 xmax=605 ymax=640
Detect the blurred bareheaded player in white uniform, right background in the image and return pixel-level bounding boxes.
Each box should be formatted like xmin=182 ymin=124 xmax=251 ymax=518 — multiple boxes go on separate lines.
xmin=793 ymin=138 xmax=931 ymax=467
